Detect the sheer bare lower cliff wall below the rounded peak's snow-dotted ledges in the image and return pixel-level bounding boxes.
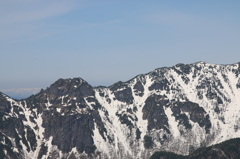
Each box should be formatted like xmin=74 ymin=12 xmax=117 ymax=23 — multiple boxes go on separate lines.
xmin=42 ymin=112 xmax=96 ymax=153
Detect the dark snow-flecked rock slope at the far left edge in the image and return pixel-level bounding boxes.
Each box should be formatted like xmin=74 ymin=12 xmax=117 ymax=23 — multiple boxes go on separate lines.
xmin=0 ymin=93 xmax=36 ymax=158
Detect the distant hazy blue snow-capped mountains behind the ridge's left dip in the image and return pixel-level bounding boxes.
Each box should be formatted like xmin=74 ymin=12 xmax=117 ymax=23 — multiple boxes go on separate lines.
xmin=0 ymin=88 xmax=41 ymax=99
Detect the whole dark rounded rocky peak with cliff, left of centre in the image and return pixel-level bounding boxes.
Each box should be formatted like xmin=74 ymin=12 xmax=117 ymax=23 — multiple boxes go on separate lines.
xmin=32 ymin=78 xmax=104 ymax=154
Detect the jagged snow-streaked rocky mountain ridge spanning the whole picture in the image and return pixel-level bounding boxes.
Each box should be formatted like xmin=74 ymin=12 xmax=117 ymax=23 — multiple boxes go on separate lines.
xmin=0 ymin=62 xmax=240 ymax=159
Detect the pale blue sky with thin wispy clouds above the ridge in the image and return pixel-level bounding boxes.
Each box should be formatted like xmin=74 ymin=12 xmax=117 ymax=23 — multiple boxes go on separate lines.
xmin=0 ymin=0 xmax=240 ymax=90
